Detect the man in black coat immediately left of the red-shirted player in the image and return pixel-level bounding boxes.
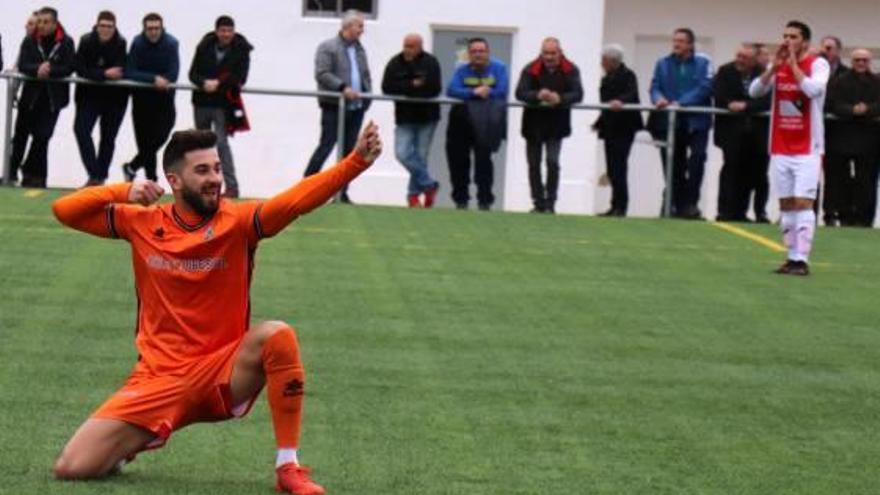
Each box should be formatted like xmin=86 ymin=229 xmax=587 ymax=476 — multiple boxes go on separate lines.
xmin=713 ymin=44 xmax=770 ymax=223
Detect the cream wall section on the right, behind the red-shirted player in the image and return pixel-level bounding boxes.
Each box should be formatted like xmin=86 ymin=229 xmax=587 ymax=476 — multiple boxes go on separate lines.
xmin=596 ymin=0 xmax=880 ymax=218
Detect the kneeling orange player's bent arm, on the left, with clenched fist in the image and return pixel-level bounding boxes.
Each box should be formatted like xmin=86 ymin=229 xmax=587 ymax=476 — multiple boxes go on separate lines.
xmin=52 ymin=181 xmax=164 ymax=237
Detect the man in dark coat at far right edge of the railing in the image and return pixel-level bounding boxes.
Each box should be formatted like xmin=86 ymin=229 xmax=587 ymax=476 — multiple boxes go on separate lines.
xmin=825 ymin=49 xmax=880 ymax=227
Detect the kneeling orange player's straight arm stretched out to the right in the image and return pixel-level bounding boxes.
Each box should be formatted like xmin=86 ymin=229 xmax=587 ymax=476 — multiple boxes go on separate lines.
xmin=251 ymin=121 xmax=382 ymax=237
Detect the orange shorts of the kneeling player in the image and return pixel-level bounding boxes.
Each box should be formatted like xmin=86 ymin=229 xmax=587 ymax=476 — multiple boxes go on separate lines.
xmin=92 ymin=341 xmax=257 ymax=448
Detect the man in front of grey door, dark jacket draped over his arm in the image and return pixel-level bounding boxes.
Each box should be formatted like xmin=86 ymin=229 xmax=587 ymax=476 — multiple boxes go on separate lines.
xmin=446 ymin=38 xmax=508 ymax=210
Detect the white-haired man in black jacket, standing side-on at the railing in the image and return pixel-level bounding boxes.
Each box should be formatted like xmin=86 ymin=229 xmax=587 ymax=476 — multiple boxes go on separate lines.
xmin=593 ymin=44 xmax=643 ymax=217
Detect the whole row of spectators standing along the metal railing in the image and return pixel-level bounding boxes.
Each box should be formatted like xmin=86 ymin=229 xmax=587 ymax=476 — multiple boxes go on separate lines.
xmin=0 ymin=7 xmax=880 ymax=226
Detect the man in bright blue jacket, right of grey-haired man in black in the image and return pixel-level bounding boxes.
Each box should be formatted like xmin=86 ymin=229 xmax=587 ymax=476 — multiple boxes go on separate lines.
xmin=650 ymin=28 xmax=712 ymax=219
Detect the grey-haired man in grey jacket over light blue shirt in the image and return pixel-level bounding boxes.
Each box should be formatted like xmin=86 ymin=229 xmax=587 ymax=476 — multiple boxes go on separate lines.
xmin=305 ymin=10 xmax=372 ymax=203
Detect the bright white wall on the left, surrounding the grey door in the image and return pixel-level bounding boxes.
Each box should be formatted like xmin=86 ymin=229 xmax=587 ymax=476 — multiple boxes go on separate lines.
xmin=0 ymin=0 xmax=604 ymax=212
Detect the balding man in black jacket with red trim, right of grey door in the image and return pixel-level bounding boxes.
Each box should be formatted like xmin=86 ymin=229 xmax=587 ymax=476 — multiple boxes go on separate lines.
xmin=516 ymin=38 xmax=584 ymax=213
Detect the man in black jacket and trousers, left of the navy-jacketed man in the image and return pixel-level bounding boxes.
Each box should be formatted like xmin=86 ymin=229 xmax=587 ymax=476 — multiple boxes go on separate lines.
xmin=73 ymin=10 xmax=128 ymax=190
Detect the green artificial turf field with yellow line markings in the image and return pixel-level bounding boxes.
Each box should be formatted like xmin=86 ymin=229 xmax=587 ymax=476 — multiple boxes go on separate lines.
xmin=0 ymin=188 xmax=880 ymax=494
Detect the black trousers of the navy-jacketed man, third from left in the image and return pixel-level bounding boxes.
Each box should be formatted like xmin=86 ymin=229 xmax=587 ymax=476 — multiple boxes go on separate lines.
xmin=129 ymin=90 xmax=177 ymax=180
